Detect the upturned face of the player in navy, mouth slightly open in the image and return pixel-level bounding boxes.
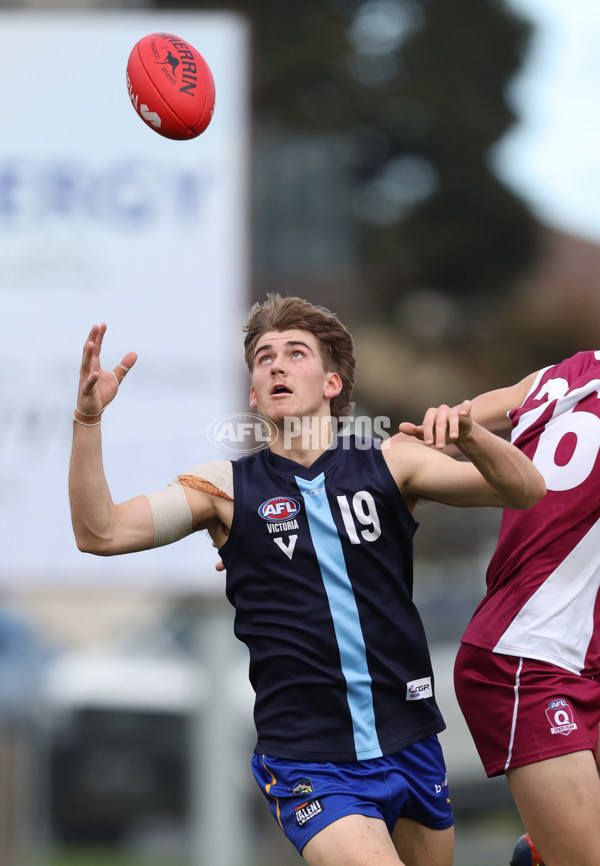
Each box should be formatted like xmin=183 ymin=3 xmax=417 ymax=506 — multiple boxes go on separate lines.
xmin=250 ymin=328 xmax=342 ymax=422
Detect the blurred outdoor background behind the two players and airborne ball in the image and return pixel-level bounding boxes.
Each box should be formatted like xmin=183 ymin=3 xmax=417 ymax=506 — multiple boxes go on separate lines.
xmin=0 ymin=0 xmax=600 ymax=866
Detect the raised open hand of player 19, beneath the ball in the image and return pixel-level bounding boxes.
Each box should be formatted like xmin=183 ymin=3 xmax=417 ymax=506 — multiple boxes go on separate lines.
xmin=77 ymin=322 xmax=137 ymax=417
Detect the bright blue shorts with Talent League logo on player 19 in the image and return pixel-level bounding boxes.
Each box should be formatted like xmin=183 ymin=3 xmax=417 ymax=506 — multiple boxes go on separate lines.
xmin=252 ymin=736 xmax=454 ymax=852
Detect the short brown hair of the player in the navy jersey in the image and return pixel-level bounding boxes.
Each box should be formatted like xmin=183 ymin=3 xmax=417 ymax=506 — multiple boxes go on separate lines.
xmin=243 ymin=294 xmax=356 ymax=419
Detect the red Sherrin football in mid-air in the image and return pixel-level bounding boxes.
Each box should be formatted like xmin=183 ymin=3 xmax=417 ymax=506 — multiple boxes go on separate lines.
xmin=127 ymin=33 xmax=215 ymax=141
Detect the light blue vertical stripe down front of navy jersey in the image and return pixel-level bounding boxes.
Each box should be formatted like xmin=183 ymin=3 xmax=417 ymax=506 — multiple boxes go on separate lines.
xmin=295 ymin=472 xmax=382 ymax=759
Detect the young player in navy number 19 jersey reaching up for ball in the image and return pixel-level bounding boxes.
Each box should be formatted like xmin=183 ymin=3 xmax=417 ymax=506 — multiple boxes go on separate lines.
xmin=70 ymin=295 xmax=545 ymax=866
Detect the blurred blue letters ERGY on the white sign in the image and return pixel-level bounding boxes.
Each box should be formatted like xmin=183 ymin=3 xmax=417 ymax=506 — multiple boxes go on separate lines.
xmin=0 ymin=159 xmax=215 ymax=232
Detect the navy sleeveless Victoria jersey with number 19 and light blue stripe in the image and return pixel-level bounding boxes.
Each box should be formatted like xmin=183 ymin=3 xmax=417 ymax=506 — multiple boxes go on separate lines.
xmin=220 ymin=437 xmax=445 ymax=761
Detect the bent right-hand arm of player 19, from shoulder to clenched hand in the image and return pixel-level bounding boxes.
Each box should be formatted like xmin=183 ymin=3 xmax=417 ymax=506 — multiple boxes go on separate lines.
xmin=384 ymin=401 xmax=546 ymax=509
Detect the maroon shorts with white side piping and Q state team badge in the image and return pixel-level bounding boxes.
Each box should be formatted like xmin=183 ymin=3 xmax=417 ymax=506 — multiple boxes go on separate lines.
xmin=454 ymin=644 xmax=600 ymax=776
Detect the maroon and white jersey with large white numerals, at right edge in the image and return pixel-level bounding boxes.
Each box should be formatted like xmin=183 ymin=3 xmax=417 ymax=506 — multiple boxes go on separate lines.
xmin=463 ymin=351 xmax=600 ymax=676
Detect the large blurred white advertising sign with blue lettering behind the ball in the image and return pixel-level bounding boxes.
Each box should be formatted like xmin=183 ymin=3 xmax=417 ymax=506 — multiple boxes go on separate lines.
xmin=0 ymin=11 xmax=250 ymax=591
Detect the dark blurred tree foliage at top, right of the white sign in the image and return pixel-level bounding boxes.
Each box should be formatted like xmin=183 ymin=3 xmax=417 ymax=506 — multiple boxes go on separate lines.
xmin=156 ymin=0 xmax=536 ymax=316
